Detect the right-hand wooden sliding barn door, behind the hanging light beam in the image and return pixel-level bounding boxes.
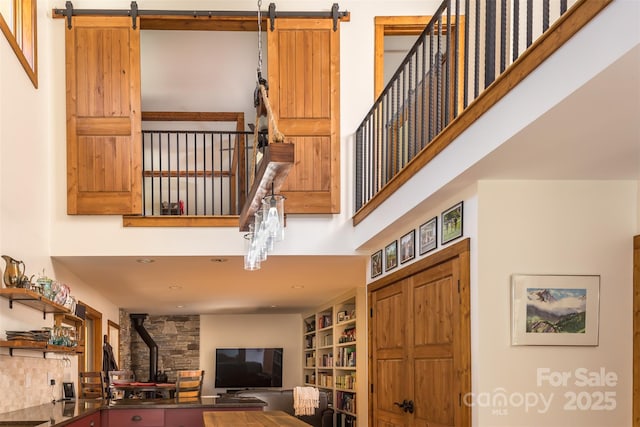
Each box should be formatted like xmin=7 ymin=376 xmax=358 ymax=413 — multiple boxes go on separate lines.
xmin=267 ymin=18 xmax=340 ymax=213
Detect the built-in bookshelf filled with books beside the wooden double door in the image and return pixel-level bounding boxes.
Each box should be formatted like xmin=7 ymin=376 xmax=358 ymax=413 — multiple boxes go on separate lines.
xmin=303 ymin=289 xmax=367 ymax=427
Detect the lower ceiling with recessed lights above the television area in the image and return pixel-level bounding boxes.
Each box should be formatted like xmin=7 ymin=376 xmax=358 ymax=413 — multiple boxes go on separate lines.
xmin=53 ymin=256 xmax=366 ymax=315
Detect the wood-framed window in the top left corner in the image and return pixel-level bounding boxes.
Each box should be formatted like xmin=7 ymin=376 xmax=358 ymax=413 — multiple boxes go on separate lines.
xmin=0 ymin=0 xmax=38 ymax=89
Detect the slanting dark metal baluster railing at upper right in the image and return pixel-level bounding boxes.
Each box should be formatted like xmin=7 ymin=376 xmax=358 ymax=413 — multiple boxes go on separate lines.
xmin=354 ymin=0 xmax=584 ymax=216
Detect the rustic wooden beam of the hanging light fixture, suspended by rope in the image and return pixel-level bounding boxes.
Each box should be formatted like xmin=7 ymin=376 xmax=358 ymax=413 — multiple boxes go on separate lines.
xmin=239 ymin=143 xmax=295 ymax=231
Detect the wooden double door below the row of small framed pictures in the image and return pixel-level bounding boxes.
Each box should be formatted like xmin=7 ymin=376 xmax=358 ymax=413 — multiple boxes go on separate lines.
xmin=369 ymin=240 xmax=471 ymax=427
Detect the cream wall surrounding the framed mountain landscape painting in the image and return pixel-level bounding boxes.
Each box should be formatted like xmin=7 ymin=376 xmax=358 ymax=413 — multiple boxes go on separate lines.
xmin=472 ymin=181 xmax=639 ymax=427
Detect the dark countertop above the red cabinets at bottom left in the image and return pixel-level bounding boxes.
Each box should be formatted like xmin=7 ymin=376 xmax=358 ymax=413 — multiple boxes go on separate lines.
xmin=0 ymin=395 xmax=266 ymax=427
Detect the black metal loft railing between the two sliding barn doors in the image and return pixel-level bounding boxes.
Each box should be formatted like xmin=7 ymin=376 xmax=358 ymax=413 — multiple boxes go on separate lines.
xmin=142 ymin=130 xmax=252 ymax=216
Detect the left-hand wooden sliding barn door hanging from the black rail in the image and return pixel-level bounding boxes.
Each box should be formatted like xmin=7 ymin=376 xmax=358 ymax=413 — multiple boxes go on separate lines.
xmin=65 ymin=16 xmax=142 ymax=214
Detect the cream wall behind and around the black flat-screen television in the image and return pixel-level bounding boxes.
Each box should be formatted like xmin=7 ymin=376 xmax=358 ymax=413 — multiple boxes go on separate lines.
xmin=200 ymin=314 xmax=302 ymax=396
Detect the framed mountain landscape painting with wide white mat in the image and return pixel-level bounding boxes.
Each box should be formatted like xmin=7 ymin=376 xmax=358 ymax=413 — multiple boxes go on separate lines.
xmin=511 ymin=274 xmax=600 ymax=346
